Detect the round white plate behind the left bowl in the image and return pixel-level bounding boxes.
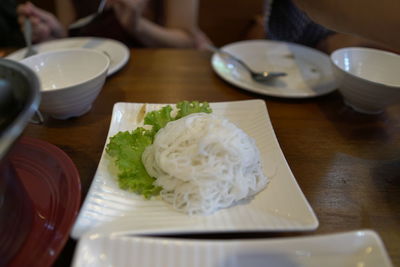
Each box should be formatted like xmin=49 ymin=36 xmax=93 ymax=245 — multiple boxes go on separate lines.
xmin=6 ymin=37 xmax=130 ymax=76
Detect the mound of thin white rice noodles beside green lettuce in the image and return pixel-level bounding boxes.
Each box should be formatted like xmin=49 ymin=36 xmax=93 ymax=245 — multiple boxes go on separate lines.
xmin=142 ymin=113 xmax=268 ymax=214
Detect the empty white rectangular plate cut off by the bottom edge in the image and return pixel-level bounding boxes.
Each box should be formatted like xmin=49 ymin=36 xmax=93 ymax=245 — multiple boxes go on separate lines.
xmin=72 ymin=230 xmax=392 ymax=267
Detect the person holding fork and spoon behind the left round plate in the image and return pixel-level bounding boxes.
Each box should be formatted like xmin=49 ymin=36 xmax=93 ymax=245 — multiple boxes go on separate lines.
xmin=17 ymin=0 xmax=211 ymax=49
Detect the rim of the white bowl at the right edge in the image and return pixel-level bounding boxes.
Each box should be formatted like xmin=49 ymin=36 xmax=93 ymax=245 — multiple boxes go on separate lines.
xmin=330 ymin=46 xmax=400 ymax=90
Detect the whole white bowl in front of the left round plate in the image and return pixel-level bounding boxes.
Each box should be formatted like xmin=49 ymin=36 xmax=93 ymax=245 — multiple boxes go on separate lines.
xmin=21 ymin=48 xmax=110 ymax=119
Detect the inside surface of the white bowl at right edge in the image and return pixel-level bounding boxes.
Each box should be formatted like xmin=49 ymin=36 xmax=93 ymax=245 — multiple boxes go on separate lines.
xmin=331 ymin=47 xmax=400 ymax=87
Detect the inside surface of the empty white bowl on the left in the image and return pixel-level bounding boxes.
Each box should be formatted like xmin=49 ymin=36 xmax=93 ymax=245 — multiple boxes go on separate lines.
xmin=22 ymin=49 xmax=109 ymax=91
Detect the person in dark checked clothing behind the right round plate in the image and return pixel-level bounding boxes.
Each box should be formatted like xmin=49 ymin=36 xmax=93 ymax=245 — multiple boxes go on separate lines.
xmin=264 ymin=0 xmax=387 ymax=54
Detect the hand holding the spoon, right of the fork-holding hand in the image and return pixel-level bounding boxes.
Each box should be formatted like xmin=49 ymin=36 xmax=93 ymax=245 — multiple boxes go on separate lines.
xmin=107 ymin=0 xmax=148 ymax=34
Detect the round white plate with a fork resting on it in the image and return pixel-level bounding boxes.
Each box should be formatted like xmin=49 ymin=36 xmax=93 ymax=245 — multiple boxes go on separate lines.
xmin=211 ymin=40 xmax=336 ymax=98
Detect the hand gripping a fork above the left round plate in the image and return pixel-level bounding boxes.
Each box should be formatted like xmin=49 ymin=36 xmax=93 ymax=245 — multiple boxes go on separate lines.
xmin=17 ymin=2 xmax=67 ymax=43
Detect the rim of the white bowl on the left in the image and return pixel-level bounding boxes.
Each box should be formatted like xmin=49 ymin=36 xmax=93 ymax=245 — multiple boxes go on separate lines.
xmin=20 ymin=47 xmax=111 ymax=94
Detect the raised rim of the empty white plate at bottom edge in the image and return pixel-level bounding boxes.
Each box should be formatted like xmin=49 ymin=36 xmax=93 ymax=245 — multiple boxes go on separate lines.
xmin=72 ymin=229 xmax=392 ymax=267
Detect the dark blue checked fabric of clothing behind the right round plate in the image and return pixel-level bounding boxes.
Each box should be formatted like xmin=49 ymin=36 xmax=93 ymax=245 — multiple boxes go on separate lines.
xmin=266 ymin=0 xmax=334 ymax=47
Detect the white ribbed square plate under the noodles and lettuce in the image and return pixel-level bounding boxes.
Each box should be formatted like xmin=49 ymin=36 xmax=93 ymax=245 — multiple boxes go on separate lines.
xmin=71 ymin=100 xmax=318 ymax=238
